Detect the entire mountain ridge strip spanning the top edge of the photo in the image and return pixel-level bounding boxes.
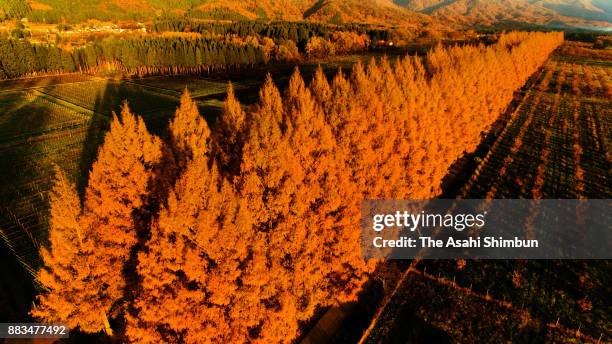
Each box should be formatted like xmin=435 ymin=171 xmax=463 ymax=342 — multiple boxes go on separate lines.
xmin=0 ymin=0 xmax=612 ymax=29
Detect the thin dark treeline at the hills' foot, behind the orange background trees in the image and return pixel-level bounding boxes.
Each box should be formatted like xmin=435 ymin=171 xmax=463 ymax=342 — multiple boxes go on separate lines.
xmin=152 ymin=19 xmax=389 ymax=47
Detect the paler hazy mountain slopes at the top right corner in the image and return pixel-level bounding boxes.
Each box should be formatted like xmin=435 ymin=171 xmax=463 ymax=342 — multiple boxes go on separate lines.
xmin=396 ymin=0 xmax=612 ymax=27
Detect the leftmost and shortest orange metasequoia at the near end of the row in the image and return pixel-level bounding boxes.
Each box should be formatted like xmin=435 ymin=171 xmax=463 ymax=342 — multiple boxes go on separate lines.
xmin=31 ymin=166 xmax=112 ymax=334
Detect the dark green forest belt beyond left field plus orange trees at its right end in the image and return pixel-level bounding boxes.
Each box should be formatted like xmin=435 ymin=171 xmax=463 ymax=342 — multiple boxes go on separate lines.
xmin=0 ymin=30 xmax=369 ymax=79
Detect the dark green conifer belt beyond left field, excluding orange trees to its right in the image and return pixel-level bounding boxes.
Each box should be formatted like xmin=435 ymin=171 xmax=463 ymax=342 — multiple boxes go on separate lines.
xmin=0 ymin=37 xmax=265 ymax=79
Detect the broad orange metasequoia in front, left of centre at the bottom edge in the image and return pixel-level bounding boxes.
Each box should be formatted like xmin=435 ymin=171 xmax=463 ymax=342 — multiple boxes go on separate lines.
xmin=126 ymin=157 xmax=251 ymax=343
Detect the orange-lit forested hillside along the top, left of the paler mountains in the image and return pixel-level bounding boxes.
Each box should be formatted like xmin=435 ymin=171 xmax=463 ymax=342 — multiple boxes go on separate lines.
xmin=0 ymin=0 xmax=430 ymax=26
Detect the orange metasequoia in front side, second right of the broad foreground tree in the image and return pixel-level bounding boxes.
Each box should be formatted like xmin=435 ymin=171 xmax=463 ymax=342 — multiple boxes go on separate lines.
xmin=279 ymin=69 xmax=365 ymax=304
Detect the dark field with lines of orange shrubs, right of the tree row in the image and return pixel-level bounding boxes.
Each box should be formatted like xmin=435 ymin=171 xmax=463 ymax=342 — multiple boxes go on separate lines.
xmin=358 ymin=43 xmax=612 ymax=343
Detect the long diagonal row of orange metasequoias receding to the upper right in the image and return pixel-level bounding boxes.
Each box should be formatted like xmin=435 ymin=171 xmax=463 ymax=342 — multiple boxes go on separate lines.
xmin=32 ymin=33 xmax=563 ymax=343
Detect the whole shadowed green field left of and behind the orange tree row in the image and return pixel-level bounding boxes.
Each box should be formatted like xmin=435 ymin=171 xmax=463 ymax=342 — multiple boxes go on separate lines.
xmin=0 ymin=55 xmax=378 ymax=321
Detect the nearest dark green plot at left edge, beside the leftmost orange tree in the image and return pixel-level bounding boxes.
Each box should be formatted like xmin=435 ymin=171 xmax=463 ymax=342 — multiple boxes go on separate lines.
xmin=0 ymin=128 xmax=101 ymax=266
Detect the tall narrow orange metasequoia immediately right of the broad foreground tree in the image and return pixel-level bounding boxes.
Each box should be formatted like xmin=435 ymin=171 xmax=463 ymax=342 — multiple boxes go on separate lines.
xmin=238 ymin=75 xmax=304 ymax=342
